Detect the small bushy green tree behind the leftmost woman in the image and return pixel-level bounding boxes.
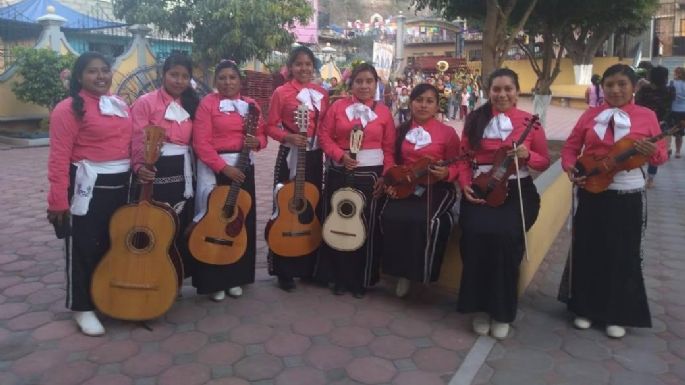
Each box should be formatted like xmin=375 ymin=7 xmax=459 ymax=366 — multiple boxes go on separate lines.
xmin=12 ymin=47 xmax=76 ymax=112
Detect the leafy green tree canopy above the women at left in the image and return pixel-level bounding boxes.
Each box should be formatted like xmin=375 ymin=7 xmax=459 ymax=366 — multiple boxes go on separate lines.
xmin=114 ymin=0 xmax=313 ymax=65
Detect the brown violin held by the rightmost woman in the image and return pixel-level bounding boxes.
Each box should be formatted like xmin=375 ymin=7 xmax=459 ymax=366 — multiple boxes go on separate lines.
xmin=575 ymin=127 xmax=679 ymax=194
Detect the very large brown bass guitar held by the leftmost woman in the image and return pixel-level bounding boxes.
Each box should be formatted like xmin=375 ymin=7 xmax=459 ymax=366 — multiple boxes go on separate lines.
xmin=91 ymin=126 xmax=182 ymax=321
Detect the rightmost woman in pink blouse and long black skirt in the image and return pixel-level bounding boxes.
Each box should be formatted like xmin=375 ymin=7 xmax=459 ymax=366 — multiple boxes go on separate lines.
xmin=559 ymin=64 xmax=667 ymax=338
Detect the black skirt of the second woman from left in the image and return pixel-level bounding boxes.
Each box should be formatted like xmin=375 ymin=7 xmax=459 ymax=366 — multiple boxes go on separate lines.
xmin=132 ymin=155 xmax=195 ymax=278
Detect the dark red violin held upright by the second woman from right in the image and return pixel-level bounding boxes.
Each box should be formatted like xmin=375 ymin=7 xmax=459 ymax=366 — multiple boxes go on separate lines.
xmin=471 ymin=115 xmax=540 ymax=207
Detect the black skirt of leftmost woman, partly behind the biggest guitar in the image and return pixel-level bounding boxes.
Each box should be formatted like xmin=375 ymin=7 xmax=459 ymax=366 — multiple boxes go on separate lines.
xmin=65 ymin=166 xmax=131 ymax=311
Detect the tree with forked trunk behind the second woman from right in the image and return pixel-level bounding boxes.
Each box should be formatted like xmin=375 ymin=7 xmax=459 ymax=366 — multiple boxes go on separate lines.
xmin=412 ymin=0 xmax=538 ymax=76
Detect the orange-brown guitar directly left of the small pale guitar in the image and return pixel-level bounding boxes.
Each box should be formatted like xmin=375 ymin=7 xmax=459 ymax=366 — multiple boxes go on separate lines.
xmin=264 ymin=104 xmax=321 ymax=257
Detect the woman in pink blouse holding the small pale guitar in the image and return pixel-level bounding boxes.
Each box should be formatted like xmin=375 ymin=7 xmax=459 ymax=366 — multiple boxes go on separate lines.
xmin=316 ymin=63 xmax=395 ymax=298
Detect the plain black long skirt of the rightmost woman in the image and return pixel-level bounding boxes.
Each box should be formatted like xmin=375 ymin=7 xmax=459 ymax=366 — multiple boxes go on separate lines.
xmin=559 ymin=189 xmax=652 ymax=327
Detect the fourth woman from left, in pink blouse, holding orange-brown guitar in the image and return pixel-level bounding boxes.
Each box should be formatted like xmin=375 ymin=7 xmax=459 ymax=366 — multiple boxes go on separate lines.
xmin=266 ymin=46 xmax=328 ymax=291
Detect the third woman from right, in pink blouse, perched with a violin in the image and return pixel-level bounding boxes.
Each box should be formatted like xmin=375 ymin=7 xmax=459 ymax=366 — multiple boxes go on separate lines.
xmin=381 ymin=83 xmax=459 ymax=297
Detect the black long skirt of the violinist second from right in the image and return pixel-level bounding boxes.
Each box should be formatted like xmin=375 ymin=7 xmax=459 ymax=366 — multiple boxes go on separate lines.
xmin=457 ymin=177 xmax=540 ymax=323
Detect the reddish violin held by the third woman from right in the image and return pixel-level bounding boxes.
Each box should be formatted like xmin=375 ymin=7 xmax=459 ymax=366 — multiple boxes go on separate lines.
xmin=383 ymin=155 xmax=470 ymax=199
